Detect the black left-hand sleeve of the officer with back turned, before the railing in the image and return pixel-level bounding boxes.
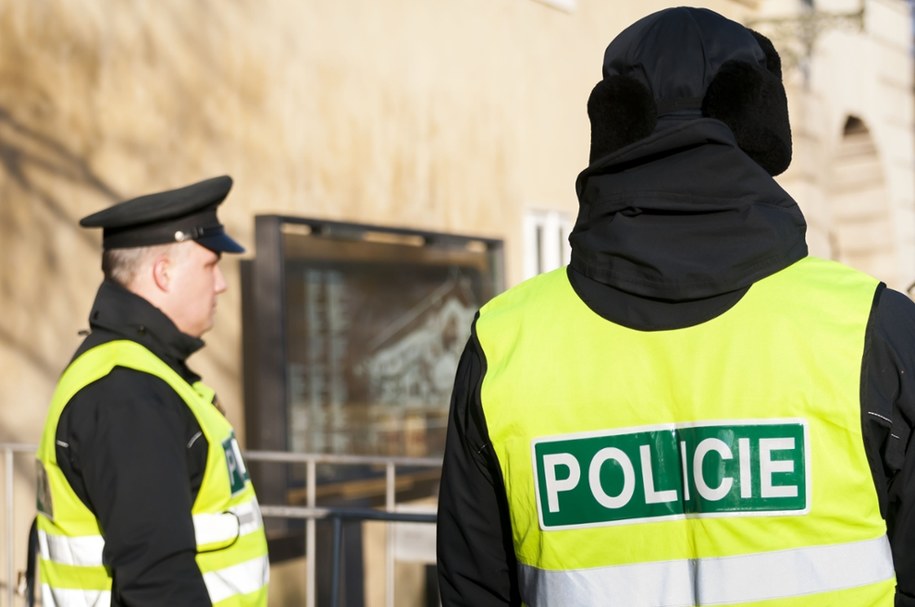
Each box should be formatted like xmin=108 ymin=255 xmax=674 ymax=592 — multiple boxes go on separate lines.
xmin=437 ymin=320 xmax=521 ymax=607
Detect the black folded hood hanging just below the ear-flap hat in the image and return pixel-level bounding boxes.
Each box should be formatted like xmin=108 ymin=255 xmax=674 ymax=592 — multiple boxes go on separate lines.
xmin=569 ymin=118 xmax=807 ymax=301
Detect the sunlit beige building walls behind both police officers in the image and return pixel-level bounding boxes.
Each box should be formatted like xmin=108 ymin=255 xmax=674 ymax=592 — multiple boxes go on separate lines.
xmin=0 ymin=0 xmax=915 ymax=600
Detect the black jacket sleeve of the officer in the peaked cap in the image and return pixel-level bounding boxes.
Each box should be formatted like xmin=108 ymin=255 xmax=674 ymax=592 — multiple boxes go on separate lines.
xmin=57 ymin=368 xmax=210 ymax=607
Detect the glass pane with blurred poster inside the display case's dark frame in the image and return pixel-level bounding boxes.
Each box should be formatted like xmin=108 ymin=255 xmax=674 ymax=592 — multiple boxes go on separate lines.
xmin=284 ymin=234 xmax=493 ymax=457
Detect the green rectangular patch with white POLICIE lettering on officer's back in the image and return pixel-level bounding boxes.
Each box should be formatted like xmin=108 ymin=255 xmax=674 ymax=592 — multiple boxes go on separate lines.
xmin=531 ymin=420 xmax=810 ymax=529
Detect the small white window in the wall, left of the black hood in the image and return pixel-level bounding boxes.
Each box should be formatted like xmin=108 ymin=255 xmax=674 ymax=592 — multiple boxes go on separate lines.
xmin=524 ymin=210 xmax=573 ymax=278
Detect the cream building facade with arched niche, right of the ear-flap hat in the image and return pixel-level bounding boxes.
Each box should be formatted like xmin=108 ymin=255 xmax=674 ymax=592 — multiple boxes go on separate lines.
xmin=758 ymin=0 xmax=915 ymax=290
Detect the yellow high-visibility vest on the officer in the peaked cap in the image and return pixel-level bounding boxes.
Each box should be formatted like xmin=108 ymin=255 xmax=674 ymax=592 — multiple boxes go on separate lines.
xmin=37 ymin=340 xmax=269 ymax=607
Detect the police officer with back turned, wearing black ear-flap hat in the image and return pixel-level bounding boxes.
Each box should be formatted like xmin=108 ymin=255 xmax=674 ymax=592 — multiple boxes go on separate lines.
xmin=438 ymin=7 xmax=915 ymax=607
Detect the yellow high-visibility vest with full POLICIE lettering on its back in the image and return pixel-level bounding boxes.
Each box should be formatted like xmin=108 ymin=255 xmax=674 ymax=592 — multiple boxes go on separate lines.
xmin=476 ymin=258 xmax=895 ymax=607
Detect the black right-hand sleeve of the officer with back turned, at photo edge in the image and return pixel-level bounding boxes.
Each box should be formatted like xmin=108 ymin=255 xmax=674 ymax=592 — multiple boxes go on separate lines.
xmin=861 ymin=286 xmax=915 ymax=607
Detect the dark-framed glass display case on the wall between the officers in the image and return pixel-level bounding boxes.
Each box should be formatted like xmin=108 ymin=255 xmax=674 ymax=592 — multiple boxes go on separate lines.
xmin=243 ymin=215 xmax=503 ymax=502
